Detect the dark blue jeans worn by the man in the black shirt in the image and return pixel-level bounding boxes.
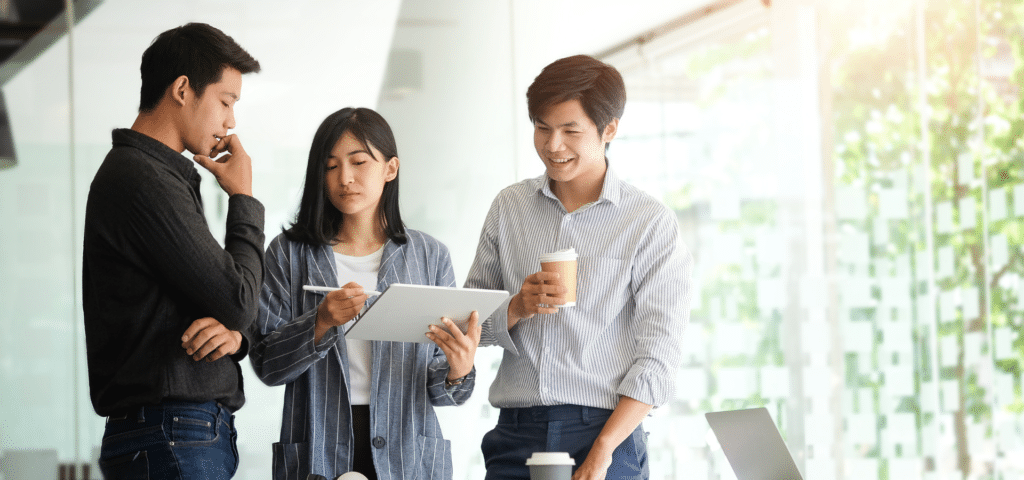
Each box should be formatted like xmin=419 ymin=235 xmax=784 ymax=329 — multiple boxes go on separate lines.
xmin=99 ymin=401 xmax=239 ymax=480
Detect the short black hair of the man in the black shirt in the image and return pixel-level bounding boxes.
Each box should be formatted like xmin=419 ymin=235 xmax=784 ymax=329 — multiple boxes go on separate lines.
xmin=138 ymin=24 xmax=260 ymax=112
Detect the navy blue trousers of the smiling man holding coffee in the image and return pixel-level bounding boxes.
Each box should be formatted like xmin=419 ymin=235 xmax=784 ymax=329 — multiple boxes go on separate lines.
xmin=480 ymin=405 xmax=650 ymax=480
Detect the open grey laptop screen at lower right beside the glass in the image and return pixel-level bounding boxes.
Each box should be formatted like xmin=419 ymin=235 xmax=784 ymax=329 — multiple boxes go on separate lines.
xmin=705 ymin=406 xmax=804 ymax=480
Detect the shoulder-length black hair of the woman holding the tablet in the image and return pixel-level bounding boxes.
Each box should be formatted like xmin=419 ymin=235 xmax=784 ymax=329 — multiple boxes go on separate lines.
xmin=284 ymin=107 xmax=407 ymax=245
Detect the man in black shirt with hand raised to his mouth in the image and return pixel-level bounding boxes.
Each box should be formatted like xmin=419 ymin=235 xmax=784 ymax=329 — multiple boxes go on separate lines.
xmin=82 ymin=24 xmax=264 ymax=479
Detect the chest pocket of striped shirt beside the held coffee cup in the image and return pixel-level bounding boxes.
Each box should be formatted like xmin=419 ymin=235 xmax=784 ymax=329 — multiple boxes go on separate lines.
xmin=570 ymin=257 xmax=631 ymax=323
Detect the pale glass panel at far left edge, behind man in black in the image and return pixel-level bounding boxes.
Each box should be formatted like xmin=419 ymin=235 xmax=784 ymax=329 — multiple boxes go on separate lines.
xmin=0 ymin=12 xmax=77 ymax=478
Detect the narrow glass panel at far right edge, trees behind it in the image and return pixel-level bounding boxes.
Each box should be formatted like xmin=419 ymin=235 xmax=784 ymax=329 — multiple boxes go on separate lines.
xmin=974 ymin=0 xmax=1024 ymax=479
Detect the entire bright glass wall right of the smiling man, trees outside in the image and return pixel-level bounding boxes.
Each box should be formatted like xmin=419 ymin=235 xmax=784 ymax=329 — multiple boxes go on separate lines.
xmin=608 ymin=0 xmax=1024 ymax=479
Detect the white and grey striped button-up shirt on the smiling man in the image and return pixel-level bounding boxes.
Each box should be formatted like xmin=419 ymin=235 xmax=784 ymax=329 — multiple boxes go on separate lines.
xmin=465 ymin=167 xmax=692 ymax=409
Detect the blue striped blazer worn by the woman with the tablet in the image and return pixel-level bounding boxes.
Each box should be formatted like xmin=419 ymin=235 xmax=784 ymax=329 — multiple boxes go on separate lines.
xmin=249 ymin=229 xmax=476 ymax=480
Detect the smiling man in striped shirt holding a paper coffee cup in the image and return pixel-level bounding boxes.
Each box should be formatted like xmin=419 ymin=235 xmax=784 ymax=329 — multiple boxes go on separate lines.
xmin=465 ymin=55 xmax=692 ymax=480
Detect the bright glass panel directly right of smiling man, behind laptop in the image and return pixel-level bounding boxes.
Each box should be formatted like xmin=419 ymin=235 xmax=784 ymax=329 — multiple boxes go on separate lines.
xmin=609 ymin=5 xmax=806 ymax=478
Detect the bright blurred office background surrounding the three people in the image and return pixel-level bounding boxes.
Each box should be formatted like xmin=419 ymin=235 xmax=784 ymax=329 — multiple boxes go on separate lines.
xmin=0 ymin=0 xmax=1024 ymax=480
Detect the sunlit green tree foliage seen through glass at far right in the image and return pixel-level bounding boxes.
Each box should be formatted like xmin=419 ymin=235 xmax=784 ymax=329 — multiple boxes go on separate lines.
xmin=829 ymin=0 xmax=1024 ymax=463
